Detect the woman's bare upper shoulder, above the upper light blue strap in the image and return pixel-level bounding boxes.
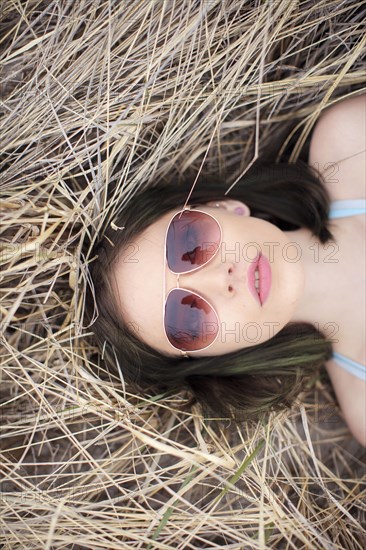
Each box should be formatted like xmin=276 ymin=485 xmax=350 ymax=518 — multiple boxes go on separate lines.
xmin=308 ymin=94 xmax=366 ymax=200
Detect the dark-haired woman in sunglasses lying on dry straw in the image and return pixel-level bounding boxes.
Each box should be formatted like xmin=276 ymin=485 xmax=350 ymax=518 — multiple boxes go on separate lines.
xmin=87 ymin=95 xmax=366 ymax=445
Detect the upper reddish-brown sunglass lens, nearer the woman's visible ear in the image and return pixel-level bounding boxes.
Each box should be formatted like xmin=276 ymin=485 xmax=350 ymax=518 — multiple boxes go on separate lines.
xmin=166 ymin=210 xmax=221 ymax=273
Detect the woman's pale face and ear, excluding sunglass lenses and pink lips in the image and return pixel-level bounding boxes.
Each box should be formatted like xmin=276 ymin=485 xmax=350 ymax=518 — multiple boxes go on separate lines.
xmin=112 ymin=200 xmax=304 ymax=357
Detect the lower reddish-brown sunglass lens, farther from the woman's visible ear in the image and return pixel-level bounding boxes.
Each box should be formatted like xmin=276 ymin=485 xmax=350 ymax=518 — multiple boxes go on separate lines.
xmin=165 ymin=288 xmax=219 ymax=351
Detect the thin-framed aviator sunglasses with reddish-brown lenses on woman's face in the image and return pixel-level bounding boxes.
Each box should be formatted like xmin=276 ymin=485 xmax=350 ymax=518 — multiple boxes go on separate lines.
xmin=163 ymin=206 xmax=222 ymax=357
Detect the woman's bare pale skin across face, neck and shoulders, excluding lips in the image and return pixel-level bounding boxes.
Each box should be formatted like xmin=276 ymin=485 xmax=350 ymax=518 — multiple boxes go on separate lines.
xmin=114 ymin=96 xmax=366 ymax=446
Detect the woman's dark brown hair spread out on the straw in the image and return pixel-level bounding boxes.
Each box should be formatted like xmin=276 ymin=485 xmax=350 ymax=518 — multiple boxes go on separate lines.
xmin=86 ymin=161 xmax=332 ymax=420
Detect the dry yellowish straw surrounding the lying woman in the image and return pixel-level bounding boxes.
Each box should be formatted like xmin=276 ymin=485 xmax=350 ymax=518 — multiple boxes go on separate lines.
xmin=0 ymin=0 xmax=366 ymax=550
